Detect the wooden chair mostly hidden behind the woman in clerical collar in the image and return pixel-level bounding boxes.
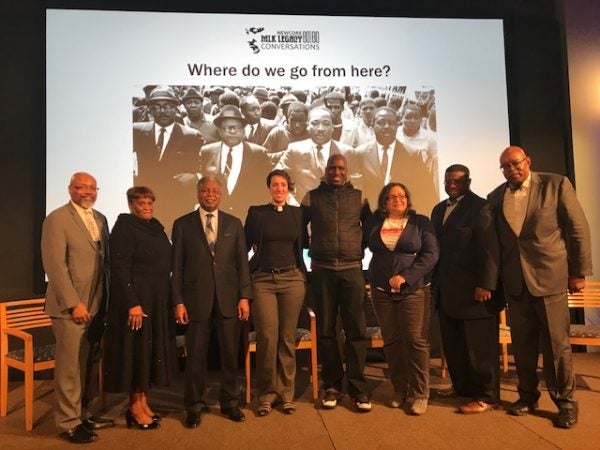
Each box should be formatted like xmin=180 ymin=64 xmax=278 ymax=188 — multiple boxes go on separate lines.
xmin=245 ymin=307 xmax=319 ymax=403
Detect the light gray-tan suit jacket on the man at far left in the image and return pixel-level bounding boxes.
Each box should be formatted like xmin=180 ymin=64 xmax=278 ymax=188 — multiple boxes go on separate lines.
xmin=42 ymin=202 xmax=108 ymax=318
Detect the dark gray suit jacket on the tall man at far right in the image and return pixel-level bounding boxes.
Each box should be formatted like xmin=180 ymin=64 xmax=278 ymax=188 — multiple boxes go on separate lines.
xmin=488 ymin=172 xmax=592 ymax=297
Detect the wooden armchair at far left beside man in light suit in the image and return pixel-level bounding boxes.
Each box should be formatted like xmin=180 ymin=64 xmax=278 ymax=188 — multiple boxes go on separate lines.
xmin=0 ymin=298 xmax=55 ymax=431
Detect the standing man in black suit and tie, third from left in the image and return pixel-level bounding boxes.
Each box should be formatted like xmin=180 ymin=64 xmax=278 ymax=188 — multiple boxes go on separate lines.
xmin=171 ymin=177 xmax=252 ymax=428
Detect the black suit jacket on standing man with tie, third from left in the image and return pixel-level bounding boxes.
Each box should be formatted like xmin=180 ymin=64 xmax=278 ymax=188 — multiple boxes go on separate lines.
xmin=171 ymin=210 xmax=252 ymax=321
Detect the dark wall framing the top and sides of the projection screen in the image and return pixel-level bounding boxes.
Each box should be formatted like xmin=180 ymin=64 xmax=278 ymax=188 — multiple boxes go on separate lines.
xmin=0 ymin=0 xmax=573 ymax=301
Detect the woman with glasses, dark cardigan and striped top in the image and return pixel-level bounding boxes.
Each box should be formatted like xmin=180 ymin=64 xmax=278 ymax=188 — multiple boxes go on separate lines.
xmin=364 ymin=183 xmax=439 ymax=415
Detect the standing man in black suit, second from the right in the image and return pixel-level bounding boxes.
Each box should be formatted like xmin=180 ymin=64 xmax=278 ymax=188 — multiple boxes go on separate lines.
xmin=431 ymin=164 xmax=501 ymax=414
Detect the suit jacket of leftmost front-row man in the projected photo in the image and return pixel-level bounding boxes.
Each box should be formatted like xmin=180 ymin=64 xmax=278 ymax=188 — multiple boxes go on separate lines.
xmin=133 ymin=122 xmax=203 ymax=234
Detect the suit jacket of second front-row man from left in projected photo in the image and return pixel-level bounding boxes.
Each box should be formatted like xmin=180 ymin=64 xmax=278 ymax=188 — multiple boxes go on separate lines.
xmin=200 ymin=141 xmax=272 ymax=220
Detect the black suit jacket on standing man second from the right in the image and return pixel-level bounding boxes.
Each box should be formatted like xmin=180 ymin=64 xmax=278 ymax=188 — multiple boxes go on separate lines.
xmin=431 ymin=191 xmax=503 ymax=319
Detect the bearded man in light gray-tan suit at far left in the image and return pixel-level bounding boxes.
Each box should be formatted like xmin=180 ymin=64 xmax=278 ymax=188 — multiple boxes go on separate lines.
xmin=42 ymin=172 xmax=114 ymax=443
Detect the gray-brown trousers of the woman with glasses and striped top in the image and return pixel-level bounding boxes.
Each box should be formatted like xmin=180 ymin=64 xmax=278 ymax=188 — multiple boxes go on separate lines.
xmin=371 ymin=286 xmax=431 ymax=398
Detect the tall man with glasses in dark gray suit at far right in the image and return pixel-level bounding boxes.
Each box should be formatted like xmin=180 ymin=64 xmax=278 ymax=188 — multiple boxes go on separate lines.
xmin=488 ymin=146 xmax=592 ymax=428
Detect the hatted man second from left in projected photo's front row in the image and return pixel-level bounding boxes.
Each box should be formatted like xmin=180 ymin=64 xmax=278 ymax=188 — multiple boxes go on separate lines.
xmin=200 ymin=105 xmax=271 ymax=220
